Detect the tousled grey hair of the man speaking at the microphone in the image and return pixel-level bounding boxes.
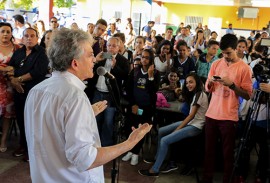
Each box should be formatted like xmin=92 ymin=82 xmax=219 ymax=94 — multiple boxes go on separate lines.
xmin=47 ymin=28 xmax=92 ymax=72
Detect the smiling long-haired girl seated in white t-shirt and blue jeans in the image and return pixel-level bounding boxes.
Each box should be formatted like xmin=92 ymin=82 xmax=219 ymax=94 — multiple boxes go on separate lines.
xmin=139 ymin=73 xmax=208 ymax=177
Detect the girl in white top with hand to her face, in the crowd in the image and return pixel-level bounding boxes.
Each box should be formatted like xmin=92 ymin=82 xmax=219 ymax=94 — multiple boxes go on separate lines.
xmin=154 ymin=40 xmax=173 ymax=77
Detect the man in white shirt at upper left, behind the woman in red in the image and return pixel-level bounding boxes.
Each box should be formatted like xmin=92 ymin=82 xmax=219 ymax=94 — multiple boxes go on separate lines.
xmin=12 ymin=15 xmax=26 ymax=45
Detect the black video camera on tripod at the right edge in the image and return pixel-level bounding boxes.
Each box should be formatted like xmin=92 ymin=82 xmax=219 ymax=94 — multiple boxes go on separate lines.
xmin=251 ymin=38 xmax=270 ymax=83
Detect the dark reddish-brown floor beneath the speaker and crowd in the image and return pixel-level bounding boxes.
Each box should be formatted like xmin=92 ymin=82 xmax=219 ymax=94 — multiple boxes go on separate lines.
xmin=0 ymin=129 xmax=262 ymax=183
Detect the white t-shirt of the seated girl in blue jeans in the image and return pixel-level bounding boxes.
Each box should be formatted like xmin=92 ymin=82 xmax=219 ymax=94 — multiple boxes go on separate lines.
xmin=188 ymin=92 xmax=208 ymax=129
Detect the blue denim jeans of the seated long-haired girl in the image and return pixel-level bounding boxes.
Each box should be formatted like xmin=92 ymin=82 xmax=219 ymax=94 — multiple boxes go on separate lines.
xmin=152 ymin=121 xmax=202 ymax=172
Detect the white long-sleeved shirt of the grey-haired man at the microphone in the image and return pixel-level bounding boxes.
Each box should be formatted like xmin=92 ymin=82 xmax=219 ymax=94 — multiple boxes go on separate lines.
xmin=24 ymin=72 xmax=104 ymax=183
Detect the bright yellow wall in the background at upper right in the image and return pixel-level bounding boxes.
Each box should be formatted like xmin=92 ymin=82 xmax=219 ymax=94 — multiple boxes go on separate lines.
xmin=164 ymin=3 xmax=270 ymax=30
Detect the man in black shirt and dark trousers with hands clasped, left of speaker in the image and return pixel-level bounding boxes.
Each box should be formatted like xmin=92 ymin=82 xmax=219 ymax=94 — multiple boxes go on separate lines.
xmin=9 ymin=28 xmax=49 ymax=161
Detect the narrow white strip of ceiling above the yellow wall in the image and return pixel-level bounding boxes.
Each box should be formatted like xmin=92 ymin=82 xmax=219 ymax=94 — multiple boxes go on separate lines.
xmin=157 ymin=0 xmax=270 ymax=8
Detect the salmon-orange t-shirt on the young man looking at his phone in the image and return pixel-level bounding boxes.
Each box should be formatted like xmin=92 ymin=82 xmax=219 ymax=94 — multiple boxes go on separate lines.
xmin=205 ymin=58 xmax=252 ymax=122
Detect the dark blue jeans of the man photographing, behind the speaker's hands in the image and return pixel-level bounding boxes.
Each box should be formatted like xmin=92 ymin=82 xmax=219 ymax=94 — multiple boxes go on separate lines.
xmin=93 ymin=90 xmax=116 ymax=147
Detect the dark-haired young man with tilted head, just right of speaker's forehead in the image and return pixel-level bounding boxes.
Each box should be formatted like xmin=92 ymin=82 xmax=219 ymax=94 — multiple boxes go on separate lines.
xmin=92 ymin=19 xmax=107 ymax=56
